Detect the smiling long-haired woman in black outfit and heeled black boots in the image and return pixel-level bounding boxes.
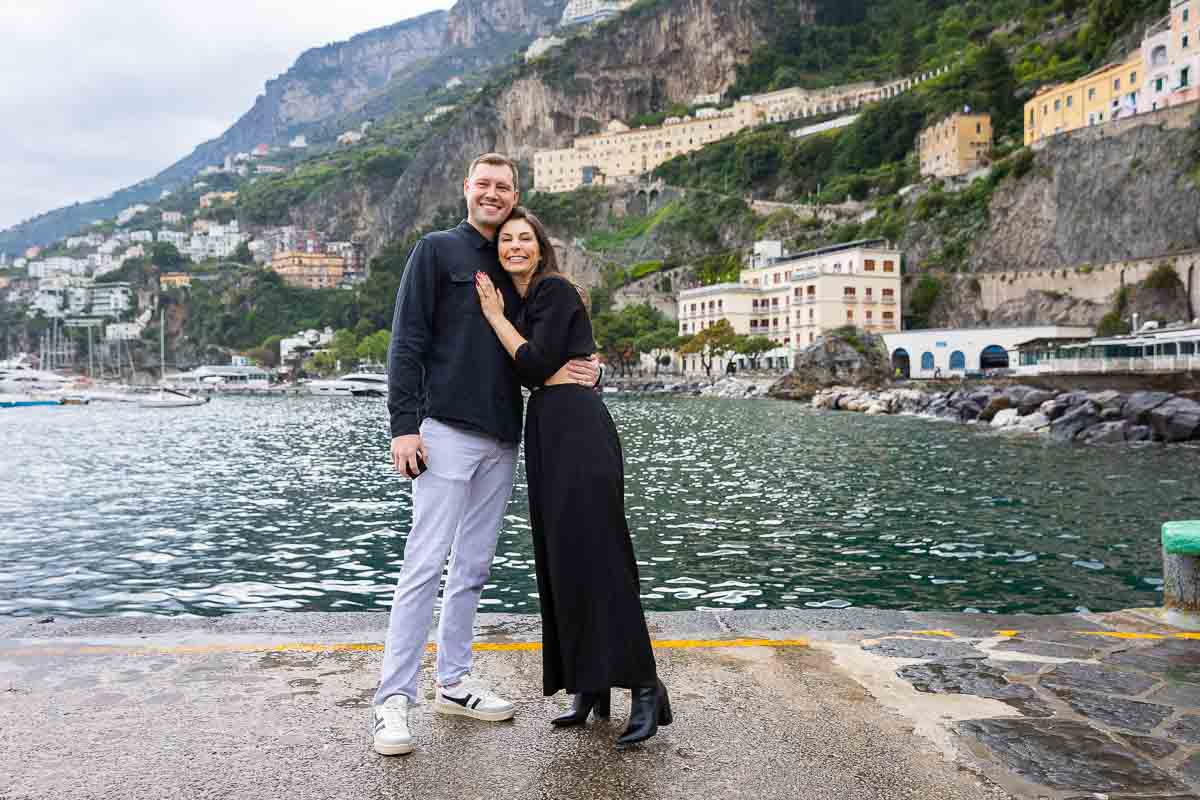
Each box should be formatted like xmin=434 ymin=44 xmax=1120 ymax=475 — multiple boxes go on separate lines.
xmin=475 ymin=206 xmax=671 ymax=747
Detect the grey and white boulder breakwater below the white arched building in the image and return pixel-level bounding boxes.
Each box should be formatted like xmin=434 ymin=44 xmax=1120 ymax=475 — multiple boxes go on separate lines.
xmin=812 ymin=386 xmax=1200 ymax=444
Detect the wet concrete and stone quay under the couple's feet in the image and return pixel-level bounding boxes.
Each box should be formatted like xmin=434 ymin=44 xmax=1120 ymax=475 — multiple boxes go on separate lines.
xmin=0 ymin=609 xmax=1200 ymax=800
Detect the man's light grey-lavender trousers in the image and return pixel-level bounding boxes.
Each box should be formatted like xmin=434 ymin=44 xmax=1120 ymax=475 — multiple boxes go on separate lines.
xmin=374 ymin=420 xmax=517 ymax=705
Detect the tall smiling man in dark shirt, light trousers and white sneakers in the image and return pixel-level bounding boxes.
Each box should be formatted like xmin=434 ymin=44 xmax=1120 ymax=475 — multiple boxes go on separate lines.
xmin=373 ymin=154 xmax=598 ymax=756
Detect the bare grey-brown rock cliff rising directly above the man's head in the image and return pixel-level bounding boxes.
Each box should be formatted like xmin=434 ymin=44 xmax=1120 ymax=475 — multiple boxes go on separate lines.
xmin=368 ymin=0 xmax=814 ymax=249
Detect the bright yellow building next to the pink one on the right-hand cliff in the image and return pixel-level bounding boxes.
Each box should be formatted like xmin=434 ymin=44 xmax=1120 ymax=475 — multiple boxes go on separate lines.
xmin=1025 ymin=49 xmax=1145 ymax=145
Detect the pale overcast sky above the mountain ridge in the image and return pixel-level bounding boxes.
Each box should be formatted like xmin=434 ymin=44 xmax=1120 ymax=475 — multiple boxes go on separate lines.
xmin=0 ymin=0 xmax=452 ymax=229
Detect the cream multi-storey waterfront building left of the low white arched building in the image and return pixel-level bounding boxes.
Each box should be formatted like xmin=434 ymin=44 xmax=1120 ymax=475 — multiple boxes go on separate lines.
xmin=678 ymin=239 xmax=901 ymax=373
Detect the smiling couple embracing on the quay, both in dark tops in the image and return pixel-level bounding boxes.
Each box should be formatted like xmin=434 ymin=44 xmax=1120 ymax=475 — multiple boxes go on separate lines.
xmin=373 ymin=154 xmax=671 ymax=756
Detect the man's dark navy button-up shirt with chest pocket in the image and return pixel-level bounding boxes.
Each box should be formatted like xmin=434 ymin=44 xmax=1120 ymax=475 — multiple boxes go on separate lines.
xmin=388 ymin=221 xmax=521 ymax=444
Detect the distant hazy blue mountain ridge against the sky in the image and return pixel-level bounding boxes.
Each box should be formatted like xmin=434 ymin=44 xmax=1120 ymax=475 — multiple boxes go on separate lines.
xmin=0 ymin=0 xmax=565 ymax=254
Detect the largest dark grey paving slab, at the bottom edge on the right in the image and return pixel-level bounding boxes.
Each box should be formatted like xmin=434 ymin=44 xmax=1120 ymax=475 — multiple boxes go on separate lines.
xmin=955 ymin=717 xmax=1190 ymax=798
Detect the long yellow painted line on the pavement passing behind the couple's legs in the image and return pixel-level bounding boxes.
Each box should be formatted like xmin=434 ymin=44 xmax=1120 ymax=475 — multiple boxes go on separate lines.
xmin=0 ymin=638 xmax=809 ymax=656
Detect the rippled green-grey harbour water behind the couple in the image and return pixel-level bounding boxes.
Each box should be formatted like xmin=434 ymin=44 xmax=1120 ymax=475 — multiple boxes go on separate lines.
xmin=0 ymin=397 xmax=1200 ymax=615
